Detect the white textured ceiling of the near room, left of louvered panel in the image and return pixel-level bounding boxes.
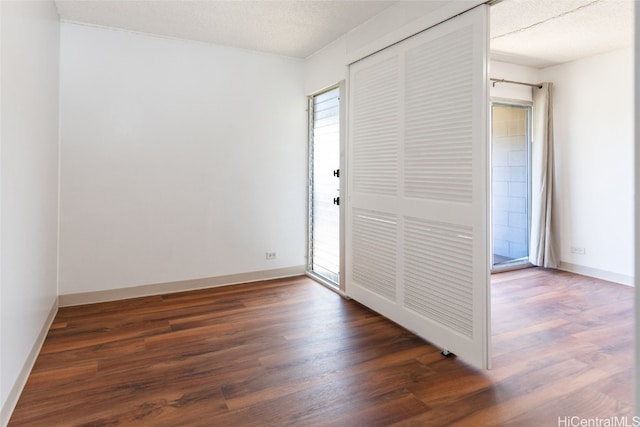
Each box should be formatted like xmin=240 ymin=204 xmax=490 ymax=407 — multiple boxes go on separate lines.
xmin=56 ymin=0 xmax=395 ymax=58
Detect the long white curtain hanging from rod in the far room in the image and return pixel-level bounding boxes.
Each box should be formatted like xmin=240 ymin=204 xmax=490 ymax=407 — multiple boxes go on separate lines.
xmin=529 ymin=83 xmax=559 ymax=268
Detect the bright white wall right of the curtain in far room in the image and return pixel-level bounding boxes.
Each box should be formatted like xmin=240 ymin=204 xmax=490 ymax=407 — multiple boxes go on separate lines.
xmin=540 ymin=49 xmax=634 ymax=284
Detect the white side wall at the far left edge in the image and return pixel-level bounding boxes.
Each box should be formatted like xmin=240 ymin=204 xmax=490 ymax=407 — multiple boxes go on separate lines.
xmin=0 ymin=1 xmax=59 ymax=425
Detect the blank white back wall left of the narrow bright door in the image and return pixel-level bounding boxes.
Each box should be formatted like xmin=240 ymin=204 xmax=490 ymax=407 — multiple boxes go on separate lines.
xmin=59 ymin=23 xmax=307 ymax=295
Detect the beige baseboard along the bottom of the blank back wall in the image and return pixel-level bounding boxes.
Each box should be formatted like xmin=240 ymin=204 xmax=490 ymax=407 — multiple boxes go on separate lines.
xmin=58 ymin=265 xmax=306 ymax=307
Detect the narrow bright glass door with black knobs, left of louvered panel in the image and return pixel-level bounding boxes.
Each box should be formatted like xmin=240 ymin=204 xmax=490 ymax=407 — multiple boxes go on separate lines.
xmin=308 ymin=87 xmax=340 ymax=287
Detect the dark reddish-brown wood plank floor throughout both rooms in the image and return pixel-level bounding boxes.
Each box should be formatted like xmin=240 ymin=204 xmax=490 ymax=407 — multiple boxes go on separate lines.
xmin=10 ymin=269 xmax=633 ymax=427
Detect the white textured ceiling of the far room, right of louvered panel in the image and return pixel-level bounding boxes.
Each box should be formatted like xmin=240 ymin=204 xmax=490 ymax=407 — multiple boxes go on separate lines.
xmin=491 ymin=0 xmax=634 ymax=68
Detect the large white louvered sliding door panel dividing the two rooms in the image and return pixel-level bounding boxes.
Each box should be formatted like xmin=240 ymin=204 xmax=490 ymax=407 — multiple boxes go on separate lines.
xmin=346 ymin=6 xmax=489 ymax=368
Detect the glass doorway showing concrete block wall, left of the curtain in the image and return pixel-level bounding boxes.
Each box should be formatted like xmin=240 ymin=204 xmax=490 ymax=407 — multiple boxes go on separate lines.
xmin=491 ymin=102 xmax=532 ymax=271
